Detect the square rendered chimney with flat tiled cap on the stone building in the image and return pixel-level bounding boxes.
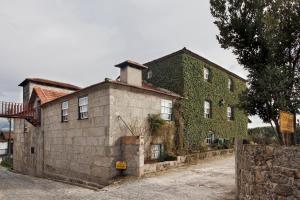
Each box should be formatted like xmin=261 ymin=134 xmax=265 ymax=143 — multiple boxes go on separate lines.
xmin=115 ymin=60 xmax=148 ymax=87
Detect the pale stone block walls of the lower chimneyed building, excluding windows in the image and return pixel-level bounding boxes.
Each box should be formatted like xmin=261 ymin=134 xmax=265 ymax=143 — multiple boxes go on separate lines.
xmin=14 ymin=80 xmax=177 ymax=185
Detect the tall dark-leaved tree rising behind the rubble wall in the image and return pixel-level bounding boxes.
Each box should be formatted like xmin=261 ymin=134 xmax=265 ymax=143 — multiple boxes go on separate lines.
xmin=210 ymin=0 xmax=300 ymax=144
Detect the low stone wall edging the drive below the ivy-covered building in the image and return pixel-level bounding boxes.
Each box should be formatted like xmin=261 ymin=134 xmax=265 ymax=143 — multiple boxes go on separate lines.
xmin=144 ymin=149 xmax=234 ymax=174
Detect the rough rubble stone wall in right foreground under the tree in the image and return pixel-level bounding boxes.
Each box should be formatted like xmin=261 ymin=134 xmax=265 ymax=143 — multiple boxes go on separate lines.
xmin=236 ymin=142 xmax=300 ymax=200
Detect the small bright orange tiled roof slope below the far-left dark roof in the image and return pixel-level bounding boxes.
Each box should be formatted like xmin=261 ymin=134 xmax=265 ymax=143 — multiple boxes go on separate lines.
xmin=33 ymin=87 xmax=68 ymax=104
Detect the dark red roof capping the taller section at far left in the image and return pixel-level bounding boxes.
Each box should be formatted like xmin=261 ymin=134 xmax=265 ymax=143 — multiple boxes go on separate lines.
xmin=19 ymin=78 xmax=81 ymax=91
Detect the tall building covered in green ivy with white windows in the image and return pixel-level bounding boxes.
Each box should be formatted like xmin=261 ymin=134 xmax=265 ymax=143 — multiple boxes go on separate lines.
xmin=143 ymin=48 xmax=248 ymax=149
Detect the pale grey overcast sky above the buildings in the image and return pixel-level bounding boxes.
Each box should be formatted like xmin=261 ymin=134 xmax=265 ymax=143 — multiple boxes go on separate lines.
xmin=0 ymin=0 xmax=263 ymax=127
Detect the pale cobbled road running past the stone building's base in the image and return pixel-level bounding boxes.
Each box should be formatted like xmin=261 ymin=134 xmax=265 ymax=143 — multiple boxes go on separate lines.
xmin=0 ymin=157 xmax=234 ymax=200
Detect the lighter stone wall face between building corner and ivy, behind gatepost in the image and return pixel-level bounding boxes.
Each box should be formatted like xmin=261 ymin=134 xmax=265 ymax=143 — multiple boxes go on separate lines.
xmin=109 ymin=83 xmax=173 ymax=174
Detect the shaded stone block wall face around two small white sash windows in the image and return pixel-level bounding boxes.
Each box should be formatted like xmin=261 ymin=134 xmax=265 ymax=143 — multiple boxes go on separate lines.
xmin=42 ymin=85 xmax=112 ymax=185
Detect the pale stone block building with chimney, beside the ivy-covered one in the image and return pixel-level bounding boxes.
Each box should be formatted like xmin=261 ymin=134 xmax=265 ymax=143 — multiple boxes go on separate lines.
xmin=9 ymin=61 xmax=181 ymax=185
